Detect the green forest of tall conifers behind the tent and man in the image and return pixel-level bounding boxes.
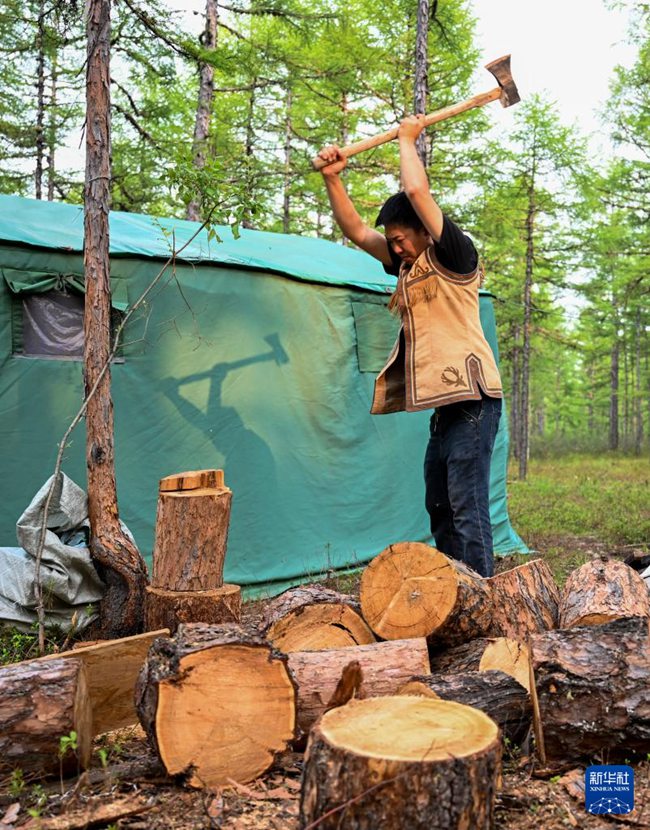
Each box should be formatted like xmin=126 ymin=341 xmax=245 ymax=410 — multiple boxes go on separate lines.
xmin=0 ymin=0 xmax=650 ymax=478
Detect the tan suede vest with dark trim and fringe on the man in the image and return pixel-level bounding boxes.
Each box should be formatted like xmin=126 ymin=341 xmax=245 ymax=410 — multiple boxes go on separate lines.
xmin=370 ymin=245 xmax=503 ymax=415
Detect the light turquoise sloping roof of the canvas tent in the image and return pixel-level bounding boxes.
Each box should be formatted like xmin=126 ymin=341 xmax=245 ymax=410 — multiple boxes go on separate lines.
xmin=0 ymin=195 xmax=395 ymax=294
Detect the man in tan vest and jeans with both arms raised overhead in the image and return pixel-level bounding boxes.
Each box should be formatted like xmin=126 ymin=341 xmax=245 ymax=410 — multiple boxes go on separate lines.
xmin=319 ymin=115 xmax=503 ymax=576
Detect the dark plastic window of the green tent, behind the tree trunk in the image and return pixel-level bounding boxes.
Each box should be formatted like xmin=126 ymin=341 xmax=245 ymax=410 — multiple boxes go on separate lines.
xmin=14 ymin=290 xmax=120 ymax=360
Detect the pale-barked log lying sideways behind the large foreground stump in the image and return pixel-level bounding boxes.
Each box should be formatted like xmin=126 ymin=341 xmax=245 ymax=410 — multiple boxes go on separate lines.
xmin=288 ymin=638 xmax=429 ymax=736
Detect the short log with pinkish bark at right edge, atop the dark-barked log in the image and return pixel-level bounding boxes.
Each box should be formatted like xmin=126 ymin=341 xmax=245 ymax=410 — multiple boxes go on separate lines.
xmin=560 ymin=559 xmax=650 ymax=628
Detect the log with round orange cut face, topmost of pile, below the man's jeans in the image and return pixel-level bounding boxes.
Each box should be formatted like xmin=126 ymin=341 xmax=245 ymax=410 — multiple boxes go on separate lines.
xmin=361 ymin=542 xmax=492 ymax=645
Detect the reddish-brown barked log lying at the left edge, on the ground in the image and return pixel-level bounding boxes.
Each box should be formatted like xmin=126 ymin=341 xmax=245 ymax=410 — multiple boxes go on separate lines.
xmin=0 ymin=659 xmax=92 ymax=779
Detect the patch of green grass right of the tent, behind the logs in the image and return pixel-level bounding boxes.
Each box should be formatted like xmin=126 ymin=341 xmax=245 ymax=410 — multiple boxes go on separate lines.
xmin=508 ymin=453 xmax=650 ymax=584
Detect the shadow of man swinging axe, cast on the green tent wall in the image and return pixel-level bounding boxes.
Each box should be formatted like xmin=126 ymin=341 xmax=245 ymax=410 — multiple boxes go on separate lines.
xmin=161 ymin=334 xmax=289 ymax=574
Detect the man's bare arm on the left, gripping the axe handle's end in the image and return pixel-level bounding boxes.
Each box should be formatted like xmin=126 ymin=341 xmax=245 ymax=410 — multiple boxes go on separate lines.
xmin=318 ymin=144 xmax=392 ymax=265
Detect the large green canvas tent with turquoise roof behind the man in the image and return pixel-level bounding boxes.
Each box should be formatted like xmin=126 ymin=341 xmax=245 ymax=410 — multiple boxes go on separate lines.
xmin=0 ymin=196 xmax=526 ymax=592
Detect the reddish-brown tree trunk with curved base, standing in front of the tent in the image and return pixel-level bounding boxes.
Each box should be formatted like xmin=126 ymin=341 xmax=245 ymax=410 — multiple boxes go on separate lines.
xmin=84 ymin=0 xmax=147 ymax=638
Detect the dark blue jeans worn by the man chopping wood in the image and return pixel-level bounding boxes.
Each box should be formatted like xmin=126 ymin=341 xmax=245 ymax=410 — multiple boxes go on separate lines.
xmin=424 ymin=393 xmax=501 ymax=576
